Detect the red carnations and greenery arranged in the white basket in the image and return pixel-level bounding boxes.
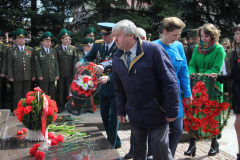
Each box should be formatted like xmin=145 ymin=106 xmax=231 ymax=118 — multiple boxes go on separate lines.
xmin=14 ymin=87 xmax=58 ymax=131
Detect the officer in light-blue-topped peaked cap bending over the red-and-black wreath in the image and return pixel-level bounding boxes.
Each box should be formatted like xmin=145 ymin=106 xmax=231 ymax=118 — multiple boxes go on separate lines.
xmin=76 ymin=23 xmax=121 ymax=148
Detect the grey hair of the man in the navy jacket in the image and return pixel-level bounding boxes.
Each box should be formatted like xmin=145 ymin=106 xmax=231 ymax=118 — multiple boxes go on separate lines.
xmin=112 ymin=19 xmax=138 ymax=39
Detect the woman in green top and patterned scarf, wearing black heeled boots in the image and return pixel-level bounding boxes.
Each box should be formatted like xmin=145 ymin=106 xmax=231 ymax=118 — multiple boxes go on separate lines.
xmin=187 ymin=23 xmax=226 ymax=156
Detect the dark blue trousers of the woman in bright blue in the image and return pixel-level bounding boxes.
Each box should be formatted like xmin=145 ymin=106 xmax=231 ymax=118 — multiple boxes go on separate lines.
xmin=169 ymin=117 xmax=183 ymax=157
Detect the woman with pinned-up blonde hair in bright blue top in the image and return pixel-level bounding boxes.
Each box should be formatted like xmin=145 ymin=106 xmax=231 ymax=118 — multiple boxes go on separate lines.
xmin=153 ymin=17 xmax=192 ymax=157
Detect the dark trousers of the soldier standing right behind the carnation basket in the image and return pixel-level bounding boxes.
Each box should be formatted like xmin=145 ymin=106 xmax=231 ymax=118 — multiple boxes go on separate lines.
xmin=39 ymin=80 xmax=55 ymax=100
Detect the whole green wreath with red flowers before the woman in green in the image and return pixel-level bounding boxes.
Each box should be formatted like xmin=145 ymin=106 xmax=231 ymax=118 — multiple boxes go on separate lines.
xmin=183 ymin=74 xmax=230 ymax=140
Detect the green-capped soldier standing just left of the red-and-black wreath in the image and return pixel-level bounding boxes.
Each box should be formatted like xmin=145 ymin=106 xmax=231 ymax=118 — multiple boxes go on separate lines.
xmin=55 ymin=29 xmax=76 ymax=113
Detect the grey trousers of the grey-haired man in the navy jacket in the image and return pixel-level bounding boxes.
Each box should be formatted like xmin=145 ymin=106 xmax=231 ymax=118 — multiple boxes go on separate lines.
xmin=131 ymin=123 xmax=173 ymax=160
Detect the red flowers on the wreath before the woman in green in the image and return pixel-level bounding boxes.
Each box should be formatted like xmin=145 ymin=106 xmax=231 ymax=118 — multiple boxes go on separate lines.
xmin=182 ymin=81 xmax=230 ymax=139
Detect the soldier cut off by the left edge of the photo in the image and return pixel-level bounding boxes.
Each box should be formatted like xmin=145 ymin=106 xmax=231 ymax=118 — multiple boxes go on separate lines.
xmin=0 ymin=31 xmax=7 ymax=109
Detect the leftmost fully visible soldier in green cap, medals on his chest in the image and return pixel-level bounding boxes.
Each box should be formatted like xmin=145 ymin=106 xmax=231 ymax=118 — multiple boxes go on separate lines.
xmin=8 ymin=29 xmax=35 ymax=110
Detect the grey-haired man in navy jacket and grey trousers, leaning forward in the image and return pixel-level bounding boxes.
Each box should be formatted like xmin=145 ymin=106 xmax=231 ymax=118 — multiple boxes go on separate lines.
xmin=112 ymin=20 xmax=179 ymax=160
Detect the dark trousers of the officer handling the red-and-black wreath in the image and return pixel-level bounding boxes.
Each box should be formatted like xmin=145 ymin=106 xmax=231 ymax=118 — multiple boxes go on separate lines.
xmin=99 ymin=94 xmax=121 ymax=148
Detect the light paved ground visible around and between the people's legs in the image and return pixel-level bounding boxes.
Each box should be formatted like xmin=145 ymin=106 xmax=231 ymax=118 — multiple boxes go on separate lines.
xmin=58 ymin=109 xmax=238 ymax=160
